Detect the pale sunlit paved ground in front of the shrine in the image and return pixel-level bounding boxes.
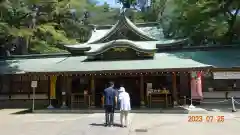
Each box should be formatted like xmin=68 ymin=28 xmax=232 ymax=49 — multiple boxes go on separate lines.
xmin=0 ymin=110 xmax=240 ymax=135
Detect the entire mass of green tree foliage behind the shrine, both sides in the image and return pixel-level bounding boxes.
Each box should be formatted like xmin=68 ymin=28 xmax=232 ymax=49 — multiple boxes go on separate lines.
xmin=0 ymin=0 xmax=240 ymax=54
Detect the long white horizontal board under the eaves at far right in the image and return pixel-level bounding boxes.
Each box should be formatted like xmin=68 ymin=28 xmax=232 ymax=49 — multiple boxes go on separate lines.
xmin=213 ymin=72 xmax=240 ymax=79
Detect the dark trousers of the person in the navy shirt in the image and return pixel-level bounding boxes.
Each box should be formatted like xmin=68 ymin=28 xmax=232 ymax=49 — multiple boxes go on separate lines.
xmin=105 ymin=105 xmax=114 ymax=126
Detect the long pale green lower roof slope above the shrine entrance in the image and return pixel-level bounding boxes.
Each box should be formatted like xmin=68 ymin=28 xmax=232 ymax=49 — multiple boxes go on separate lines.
xmin=0 ymin=53 xmax=214 ymax=74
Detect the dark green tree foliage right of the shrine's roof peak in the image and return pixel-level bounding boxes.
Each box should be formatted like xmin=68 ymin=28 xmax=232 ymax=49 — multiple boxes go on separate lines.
xmin=137 ymin=0 xmax=240 ymax=45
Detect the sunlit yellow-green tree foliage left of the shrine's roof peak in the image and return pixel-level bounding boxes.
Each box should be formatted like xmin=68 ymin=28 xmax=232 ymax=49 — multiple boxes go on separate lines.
xmin=0 ymin=0 xmax=118 ymax=54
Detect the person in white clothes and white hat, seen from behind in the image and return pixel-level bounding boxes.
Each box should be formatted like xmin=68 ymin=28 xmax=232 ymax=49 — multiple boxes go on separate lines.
xmin=119 ymin=87 xmax=131 ymax=127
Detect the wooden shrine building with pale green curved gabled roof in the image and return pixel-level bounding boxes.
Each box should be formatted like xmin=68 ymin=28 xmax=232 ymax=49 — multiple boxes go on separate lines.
xmin=0 ymin=13 xmax=240 ymax=109
